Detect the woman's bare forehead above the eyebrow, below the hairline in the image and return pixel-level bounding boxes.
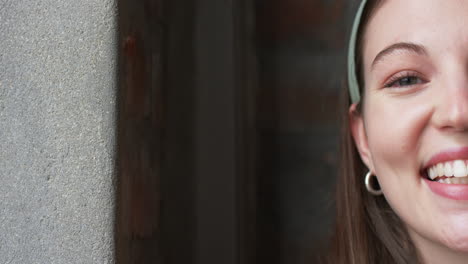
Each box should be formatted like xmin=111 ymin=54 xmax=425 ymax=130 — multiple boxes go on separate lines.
xmin=363 ymin=0 xmax=468 ymax=72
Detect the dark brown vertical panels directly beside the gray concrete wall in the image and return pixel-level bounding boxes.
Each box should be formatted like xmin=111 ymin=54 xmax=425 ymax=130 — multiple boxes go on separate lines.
xmin=116 ymin=0 xmax=256 ymax=264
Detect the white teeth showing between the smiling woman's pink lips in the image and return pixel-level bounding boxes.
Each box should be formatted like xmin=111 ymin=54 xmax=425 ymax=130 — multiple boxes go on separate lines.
xmin=425 ymin=160 xmax=468 ymax=184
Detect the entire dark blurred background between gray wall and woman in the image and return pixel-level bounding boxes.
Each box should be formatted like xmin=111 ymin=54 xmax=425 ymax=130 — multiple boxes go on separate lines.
xmin=116 ymin=0 xmax=355 ymax=264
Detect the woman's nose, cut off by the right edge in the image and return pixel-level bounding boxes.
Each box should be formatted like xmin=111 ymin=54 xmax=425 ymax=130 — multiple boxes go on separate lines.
xmin=433 ymin=70 xmax=468 ymax=131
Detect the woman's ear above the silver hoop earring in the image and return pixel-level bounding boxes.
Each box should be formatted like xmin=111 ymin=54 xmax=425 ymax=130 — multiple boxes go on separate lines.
xmin=348 ymin=104 xmax=375 ymax=172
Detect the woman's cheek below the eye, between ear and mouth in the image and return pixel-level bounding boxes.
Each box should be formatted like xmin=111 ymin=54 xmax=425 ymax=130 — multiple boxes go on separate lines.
xmin=364 ymin=98 xmax=432 ymax=194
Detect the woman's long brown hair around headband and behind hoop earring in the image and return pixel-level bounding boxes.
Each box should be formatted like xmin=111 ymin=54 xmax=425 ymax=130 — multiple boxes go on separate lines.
xmin=326 ymin=0 xmax=419 ymax=264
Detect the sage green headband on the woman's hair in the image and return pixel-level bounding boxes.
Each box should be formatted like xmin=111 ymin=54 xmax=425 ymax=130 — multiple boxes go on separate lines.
xmin=348 ymin=0 xmax=367 ymax=103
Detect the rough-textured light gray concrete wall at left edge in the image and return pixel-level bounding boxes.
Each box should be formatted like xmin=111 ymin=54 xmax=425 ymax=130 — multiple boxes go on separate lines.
xmin=0 ymin=0 xmax=116 ymax=264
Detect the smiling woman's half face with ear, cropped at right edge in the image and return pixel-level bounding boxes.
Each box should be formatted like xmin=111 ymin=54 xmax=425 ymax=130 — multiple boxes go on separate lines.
xmin=351 ymin=0 xmax=468 ymax=263
